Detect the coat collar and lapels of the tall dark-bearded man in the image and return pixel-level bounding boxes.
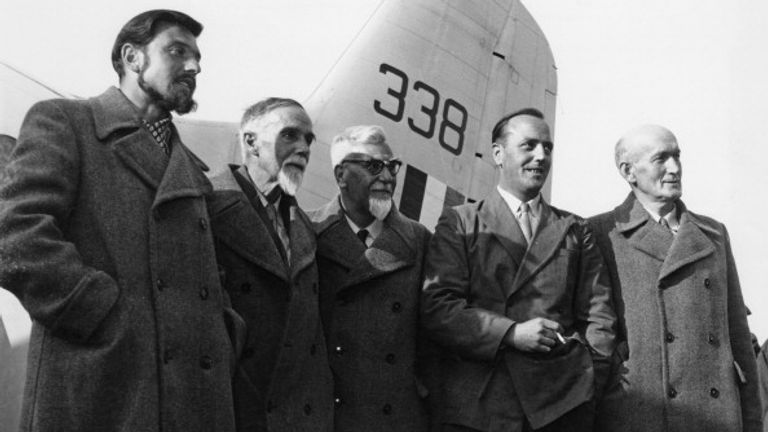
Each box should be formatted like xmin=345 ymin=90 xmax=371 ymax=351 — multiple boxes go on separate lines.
xmin=90 ymin=87 xmax=211 ymax=204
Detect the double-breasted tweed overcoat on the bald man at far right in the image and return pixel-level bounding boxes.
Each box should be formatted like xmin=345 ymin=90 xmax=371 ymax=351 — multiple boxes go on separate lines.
xmin=590 ymin=194 xmax=762 ymax=432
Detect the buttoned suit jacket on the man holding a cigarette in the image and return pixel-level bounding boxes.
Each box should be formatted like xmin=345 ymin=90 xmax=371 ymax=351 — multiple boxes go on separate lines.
xmin=422 ymin=190 xmax=615 ymax=431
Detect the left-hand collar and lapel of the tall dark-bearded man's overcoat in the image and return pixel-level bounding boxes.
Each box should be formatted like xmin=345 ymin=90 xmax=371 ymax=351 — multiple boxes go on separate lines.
xmin=91 ymin=87 xmax=168 ymax=189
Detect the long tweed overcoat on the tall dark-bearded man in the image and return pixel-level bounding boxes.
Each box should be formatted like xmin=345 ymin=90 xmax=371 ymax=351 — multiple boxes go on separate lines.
xmin=0 ymin=87 xmax=234 ymax=431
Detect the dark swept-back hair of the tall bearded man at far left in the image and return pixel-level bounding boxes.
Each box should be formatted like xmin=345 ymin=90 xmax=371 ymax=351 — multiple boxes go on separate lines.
xmin=112 ymin=9 xmax=203 ymax=78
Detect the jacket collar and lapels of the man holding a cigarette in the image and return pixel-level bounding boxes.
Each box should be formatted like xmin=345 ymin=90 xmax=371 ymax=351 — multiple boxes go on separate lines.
xmin=479 ymin=191 xmax=577 ymax=297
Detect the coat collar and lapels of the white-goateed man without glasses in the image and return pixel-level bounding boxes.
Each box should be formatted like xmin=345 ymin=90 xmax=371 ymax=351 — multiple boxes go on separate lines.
xmin=210 ymin=165 xmax=316 ymax=282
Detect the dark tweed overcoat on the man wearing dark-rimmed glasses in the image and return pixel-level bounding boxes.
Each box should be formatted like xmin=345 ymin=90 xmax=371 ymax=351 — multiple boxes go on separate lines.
xmin=310 ymin=197 xmax=430 ymax=432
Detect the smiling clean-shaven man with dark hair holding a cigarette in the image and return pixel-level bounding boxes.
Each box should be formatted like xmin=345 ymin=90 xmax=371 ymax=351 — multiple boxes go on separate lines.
xmin=422 ymin=109 xmax=615 ymax=431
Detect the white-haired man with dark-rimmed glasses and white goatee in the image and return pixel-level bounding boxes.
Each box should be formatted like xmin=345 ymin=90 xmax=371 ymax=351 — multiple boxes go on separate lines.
xmin=310 ymin=126 xmax=430 ymax=432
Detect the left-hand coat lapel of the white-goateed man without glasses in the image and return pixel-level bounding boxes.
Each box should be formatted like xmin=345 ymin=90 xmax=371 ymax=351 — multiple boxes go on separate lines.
xmin=210 ymin=167 xmax=290 ymax=281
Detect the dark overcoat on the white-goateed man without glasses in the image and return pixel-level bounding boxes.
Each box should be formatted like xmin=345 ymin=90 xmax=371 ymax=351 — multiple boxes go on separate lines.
xmin=211 ymin=166 xmax=333 ymax=432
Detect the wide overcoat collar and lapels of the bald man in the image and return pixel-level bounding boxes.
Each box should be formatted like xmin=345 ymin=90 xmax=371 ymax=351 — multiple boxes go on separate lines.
xmin=614 ymin=193 xmax=719 ymax=280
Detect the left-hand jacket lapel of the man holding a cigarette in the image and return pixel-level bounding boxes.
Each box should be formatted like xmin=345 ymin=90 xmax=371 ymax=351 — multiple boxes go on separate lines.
xmin=478 ymin=188 xmax=527 ymax=267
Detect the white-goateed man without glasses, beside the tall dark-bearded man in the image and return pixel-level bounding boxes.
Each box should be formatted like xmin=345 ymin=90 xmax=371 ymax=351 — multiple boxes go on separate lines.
xmin=210 ymin=98 xmax=333 ymax=432
